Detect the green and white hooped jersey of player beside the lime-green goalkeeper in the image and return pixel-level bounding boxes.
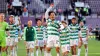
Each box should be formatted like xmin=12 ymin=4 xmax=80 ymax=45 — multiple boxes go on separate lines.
xmin=8 ymin=24 xmax=19 ymax=38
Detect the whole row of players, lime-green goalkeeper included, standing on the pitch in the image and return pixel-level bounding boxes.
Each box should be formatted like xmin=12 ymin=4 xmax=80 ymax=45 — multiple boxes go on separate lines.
xmin=0 ymin=5 xmax=88 ymax=56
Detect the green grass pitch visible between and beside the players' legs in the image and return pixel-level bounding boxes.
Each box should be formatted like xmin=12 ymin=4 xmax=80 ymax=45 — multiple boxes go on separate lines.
xmin=18 ymin=39 xmax=100 ymax=56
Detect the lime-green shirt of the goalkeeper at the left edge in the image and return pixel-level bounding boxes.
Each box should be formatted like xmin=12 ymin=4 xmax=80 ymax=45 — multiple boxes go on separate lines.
xmin=0 ymin=22 xmax=8 ymax=40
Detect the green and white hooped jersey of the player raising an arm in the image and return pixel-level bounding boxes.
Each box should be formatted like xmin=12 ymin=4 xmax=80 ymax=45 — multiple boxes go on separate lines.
xmin=47 ymin=19 xmax=60 ymax=36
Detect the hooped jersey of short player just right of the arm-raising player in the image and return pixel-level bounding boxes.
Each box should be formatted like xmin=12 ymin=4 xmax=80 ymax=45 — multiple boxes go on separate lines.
xmin=60 ymin=27 xmax=70 ymax=45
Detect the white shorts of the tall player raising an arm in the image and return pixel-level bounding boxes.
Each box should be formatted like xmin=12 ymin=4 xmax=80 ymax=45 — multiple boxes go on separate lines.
xmin=47 ymin=36 xmax=60 ymax=48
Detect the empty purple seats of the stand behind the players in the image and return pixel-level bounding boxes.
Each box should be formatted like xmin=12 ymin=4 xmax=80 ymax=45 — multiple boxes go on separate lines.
xmin=0 ymin=0 xmax=97 ymax=28
